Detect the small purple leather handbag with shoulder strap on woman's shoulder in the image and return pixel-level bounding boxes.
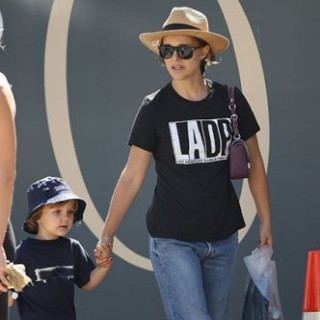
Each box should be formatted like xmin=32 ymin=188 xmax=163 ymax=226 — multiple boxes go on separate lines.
xmin=228 ymin=86 xmax=249 ymax=180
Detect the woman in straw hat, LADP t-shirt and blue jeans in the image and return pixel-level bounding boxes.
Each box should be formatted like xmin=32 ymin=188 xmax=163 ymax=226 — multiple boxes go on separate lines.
xmin=97 ymin=7 xmax=272 ymax=320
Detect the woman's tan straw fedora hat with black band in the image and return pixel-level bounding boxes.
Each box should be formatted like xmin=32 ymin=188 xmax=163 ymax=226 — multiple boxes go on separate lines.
xmin=139 ymin=7 xmax=229 ymax=54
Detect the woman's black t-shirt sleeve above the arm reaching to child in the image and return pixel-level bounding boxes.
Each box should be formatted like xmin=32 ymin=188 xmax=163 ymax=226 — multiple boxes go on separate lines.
xmin=128 ymin=98 xmax=157 ymax=153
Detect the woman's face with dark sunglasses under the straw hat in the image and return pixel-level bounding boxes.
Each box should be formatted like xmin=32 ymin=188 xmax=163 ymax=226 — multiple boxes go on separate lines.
xmin=162 ymin=36 xmax=209 ymax=80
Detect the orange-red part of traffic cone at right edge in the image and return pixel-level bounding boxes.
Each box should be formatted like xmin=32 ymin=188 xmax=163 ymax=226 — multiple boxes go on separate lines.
xmin=303 ymin=250 xmax=320 ymax=312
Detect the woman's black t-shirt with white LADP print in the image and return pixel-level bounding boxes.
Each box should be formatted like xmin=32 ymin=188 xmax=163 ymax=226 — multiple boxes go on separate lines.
xmin=128 ymin=82 xmax=259 ymax=241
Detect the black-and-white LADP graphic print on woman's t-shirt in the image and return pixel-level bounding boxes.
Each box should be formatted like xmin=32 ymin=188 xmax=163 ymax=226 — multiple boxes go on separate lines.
xmin=169 ymin=118 xmax=232 ymax=164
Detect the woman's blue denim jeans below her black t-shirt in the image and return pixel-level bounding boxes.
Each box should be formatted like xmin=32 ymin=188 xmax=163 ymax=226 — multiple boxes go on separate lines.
xmin=150 ymin=233 xmax=238 ymax=320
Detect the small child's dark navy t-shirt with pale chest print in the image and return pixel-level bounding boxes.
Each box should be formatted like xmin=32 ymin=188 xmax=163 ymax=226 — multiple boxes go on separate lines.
xmin=15 ymin=237 xmax=95 ymax=320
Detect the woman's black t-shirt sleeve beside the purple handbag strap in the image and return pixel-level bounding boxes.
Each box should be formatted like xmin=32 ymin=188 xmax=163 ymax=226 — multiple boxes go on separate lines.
xmin=234 ymin=88 xmax=260 ymax=140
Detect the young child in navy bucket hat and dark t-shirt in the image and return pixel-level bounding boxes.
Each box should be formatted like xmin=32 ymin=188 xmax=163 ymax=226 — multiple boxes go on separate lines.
xmin=15 ymin=177 xmax=112 ymax=320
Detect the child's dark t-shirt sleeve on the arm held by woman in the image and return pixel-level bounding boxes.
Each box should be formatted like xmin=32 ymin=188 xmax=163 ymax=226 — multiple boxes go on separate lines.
xmin=72 ymin=240 xmax=95 ymax=288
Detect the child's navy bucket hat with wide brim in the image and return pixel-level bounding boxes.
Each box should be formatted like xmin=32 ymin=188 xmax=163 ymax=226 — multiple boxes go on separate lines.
xmin=23 ymin=177 xmax=87 ymax=234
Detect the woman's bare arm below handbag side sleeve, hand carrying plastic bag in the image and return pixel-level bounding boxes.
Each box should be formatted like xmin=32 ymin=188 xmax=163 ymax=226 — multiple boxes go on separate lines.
xmin=246 ymin=135 xmax=273 ymax=247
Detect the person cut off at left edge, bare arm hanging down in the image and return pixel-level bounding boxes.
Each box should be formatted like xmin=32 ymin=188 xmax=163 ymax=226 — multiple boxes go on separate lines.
xmin=0 ymin=73 xmax=16 ymax=319
